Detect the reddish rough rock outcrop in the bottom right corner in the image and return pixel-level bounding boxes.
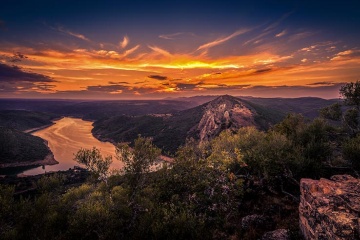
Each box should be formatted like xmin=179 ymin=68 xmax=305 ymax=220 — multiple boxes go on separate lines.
xmin=299 ymin=175 xmax=360 ymax=239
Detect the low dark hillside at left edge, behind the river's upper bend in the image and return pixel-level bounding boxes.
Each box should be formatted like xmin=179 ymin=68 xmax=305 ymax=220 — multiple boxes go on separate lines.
xmin=0 ymin=110 xmax=57 ymax=131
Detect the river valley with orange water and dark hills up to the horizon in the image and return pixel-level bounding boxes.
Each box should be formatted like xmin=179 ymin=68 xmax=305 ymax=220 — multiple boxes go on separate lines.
xmin=0 ymin=95 xmax=334 ymax=175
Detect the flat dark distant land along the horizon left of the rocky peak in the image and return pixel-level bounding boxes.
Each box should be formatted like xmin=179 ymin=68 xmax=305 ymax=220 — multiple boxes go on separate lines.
xmin=0 ymin=99 xmax=197 ymax=120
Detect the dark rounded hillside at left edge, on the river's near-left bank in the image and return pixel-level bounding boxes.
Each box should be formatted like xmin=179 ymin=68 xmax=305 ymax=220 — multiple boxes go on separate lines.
xmin=0 ymin=126 xmax=56 ymax=166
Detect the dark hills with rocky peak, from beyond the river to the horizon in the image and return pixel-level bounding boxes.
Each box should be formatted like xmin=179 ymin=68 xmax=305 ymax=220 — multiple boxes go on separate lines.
xmin=0 ymin=95 xmax=338 ymax=162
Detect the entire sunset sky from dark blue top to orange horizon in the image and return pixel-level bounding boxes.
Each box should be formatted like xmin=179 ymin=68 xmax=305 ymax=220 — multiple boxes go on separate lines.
xmin=0 ymin=0 xmax=360 ymax=99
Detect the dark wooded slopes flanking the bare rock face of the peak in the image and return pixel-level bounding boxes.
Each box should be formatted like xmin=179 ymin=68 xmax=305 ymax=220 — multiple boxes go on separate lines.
xmin=92 ymin=96 xmax=285 ymax=155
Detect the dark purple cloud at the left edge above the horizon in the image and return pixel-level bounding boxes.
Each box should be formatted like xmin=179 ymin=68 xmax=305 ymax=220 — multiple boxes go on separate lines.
xmin=0 ymin=63 xmax=55 ymax=82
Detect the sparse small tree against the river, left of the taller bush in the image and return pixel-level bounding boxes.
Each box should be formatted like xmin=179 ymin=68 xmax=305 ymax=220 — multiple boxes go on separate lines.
xmin=74 ymin=147 xmax=112 ymax=181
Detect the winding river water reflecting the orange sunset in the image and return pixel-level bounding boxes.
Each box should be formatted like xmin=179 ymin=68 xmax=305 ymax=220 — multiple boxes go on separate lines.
xmin=23 ymin=117 xmax=122 ymax=175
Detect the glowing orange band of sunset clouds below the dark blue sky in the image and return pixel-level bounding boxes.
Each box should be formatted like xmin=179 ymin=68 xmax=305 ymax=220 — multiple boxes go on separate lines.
xmin=0 ymin=0 xmax=360 ymax=99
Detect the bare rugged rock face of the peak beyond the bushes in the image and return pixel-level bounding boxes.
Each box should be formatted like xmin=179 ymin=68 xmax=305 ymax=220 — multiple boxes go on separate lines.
xmin=197 ymin=95 xmax=256 ymax=141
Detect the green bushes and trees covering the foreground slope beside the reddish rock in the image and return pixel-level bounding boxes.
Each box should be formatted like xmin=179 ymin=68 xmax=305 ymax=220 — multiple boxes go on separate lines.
xmin=0 ymin=82 xmax=360 ymax=239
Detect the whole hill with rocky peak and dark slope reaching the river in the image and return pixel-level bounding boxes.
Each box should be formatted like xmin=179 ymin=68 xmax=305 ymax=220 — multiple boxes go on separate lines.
xmin=93 ymin=95 xmax=283 ymax=153
